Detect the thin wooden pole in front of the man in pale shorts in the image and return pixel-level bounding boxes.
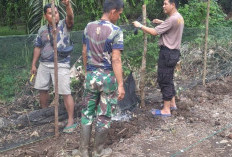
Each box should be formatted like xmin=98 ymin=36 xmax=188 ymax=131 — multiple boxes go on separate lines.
xmin=51 ymin=0 xmax=59 ymax=137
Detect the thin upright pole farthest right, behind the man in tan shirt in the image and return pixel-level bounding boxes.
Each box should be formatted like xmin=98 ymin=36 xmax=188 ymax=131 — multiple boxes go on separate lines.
xmin=202 ymin=0 xmax=210 ymax=86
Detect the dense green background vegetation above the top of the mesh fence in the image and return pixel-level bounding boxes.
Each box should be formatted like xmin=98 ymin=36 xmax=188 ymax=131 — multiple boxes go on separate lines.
xmin=0 ymin=0 xmax=232 ymax=36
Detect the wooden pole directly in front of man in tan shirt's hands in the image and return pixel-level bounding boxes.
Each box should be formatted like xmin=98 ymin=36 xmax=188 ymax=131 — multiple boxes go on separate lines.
xmin=140 ymin=4 xmax=147 ymax=108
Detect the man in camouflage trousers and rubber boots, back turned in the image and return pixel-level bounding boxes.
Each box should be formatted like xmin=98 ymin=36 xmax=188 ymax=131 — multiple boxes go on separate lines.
xmin=80 ymin=0 xmax=125 ymax=157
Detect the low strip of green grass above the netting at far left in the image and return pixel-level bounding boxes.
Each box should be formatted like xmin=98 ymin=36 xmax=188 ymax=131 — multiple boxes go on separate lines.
xmin=0 ymin=25 xmax=27 ymax=36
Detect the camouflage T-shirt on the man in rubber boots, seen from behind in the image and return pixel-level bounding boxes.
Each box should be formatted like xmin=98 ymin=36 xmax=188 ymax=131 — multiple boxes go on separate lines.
xmin=83 ymin=20 xmax=123 ymax=71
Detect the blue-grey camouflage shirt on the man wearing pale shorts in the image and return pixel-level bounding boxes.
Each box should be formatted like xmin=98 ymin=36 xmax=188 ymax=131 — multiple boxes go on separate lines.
xmin=34 ymin=20 xmax=70 ymax=64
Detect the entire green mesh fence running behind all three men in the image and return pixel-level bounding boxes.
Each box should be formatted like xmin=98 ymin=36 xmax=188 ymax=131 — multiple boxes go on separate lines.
xmin=0 ymin=25 xmax=232 ymax=100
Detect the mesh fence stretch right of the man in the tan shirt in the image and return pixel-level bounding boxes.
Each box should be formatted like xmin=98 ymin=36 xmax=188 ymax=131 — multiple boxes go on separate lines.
xmin=177 ymin=27 xmax=232 ymax=91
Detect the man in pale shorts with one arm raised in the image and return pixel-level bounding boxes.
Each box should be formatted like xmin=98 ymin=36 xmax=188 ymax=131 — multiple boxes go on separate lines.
xmin=31 ymin=0 xmax=76 ymax=132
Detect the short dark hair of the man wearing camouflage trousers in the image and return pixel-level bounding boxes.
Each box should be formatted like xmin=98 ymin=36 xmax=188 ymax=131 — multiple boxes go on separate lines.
xmin=103 ymin=0 xmax=124 ymax=13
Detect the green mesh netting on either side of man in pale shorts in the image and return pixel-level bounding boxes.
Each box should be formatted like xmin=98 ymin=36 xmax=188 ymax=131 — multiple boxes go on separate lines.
xmin=0 ymin=31 xmax=82 ymax=99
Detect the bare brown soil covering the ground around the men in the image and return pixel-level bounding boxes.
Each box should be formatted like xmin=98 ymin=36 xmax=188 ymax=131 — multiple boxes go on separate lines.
xmin=0 ymin=76 xmax=232 ymax=157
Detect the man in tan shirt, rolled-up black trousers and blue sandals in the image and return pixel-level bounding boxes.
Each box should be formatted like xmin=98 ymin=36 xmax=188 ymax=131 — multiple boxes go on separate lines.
xmin=133 ymin=0 xmax=184 ymax=117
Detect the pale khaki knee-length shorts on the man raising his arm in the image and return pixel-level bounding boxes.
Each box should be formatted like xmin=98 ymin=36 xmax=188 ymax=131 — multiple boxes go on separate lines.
xmin=34 ymin=63 xmax=71 ymax=95
